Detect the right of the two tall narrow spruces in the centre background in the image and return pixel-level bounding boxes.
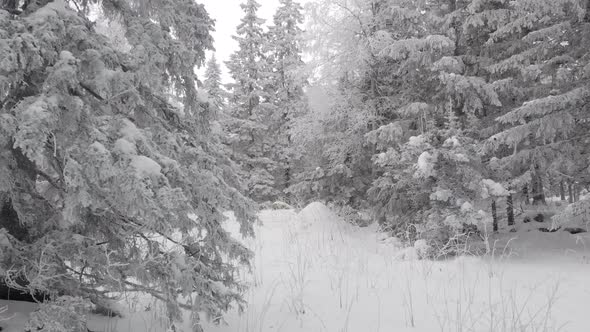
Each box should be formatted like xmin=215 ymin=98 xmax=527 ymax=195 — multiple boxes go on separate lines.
xmin=264 ymin=0 xmax=307 ymax=197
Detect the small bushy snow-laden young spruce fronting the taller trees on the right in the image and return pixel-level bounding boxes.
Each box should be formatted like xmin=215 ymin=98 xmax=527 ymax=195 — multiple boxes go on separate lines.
xmin=369 ymin=128 xmax=507 ymax=254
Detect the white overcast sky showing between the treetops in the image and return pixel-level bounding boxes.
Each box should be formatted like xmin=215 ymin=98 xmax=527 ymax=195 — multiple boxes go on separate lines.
xmin=197 ymin=0 xmax=309 ymax=83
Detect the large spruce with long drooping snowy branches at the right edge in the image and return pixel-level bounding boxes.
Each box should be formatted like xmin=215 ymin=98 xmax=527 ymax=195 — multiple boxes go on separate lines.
xmin=486 ymin=0 xmax=590 ymax=228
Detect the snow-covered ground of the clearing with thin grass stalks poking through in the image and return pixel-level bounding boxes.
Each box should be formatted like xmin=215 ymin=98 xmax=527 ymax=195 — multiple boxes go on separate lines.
xmin=0 ymin=203 xmax=590 ymax=332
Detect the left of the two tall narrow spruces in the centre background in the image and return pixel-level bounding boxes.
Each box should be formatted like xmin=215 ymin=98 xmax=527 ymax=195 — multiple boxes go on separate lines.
xmin=227 ymin=0 xmax=280 ymax=202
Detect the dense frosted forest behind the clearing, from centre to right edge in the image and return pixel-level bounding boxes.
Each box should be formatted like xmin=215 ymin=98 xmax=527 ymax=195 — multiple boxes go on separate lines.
xmin=219 ymin=0 xmax=590 ymax=242
